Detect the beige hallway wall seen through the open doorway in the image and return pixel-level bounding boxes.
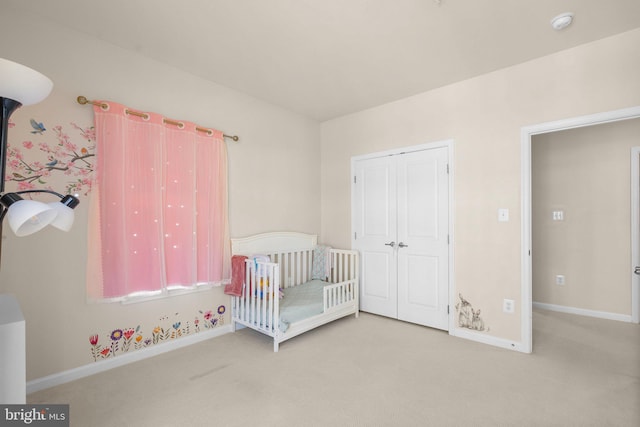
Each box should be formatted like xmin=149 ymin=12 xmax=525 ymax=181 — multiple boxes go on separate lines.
xmin=531 ymin=119 xmax=640 ymax=315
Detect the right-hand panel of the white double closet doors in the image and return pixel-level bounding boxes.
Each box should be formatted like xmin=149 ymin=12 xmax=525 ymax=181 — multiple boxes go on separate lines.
xmin=396 ymin=148 xmax=449 ymax=330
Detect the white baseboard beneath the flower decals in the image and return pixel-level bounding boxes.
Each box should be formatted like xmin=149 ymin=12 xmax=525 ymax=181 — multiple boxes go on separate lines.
xmin=27 ymin=325 xmax=232 ymax=394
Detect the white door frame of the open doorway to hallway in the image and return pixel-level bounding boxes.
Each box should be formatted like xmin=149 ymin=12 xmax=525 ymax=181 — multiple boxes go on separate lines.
xmin=520 ymin=106 xmax=640 ymax=353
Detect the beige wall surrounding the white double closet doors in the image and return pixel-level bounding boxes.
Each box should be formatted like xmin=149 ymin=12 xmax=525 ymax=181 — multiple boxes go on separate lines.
xmin=321 ymin=30 xmax=640 ymax=342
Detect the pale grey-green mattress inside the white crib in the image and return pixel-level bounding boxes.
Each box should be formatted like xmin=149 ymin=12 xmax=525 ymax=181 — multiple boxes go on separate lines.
xmin=279 ymin=280 xmax=327 ymax=332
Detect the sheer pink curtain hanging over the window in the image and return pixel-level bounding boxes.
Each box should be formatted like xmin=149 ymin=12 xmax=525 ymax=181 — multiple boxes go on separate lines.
xmin=87 ymin=101 xmax=231 ymax=299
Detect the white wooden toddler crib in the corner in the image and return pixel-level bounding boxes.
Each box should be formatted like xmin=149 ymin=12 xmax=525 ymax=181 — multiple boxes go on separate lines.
xmin=231 ymin=232 xmax=359 ymax=351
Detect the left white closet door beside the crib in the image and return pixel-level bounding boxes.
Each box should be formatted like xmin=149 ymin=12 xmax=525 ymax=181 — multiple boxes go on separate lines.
xmin=352 ymin=156 xmax=398 ymax=318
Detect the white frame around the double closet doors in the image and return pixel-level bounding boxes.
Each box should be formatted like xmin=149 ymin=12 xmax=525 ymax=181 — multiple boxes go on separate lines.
xmin=351 ymin=139 xmax=455 ymax=335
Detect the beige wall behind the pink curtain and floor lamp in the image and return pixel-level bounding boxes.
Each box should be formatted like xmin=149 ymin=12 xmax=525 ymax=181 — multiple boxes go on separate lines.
xmin=0 ymin=10 xmax=320 ymax=380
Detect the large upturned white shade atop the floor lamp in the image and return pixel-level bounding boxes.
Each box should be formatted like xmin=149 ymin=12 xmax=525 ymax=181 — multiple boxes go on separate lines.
xmin=0 ymin=58 xmax=53 ymax=105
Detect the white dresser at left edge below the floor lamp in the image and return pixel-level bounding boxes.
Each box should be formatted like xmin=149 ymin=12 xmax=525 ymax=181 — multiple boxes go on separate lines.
xmin=0 ymin=295 xmax=27 ymax=404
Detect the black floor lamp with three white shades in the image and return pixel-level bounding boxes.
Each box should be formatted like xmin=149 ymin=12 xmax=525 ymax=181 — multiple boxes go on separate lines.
xmin=0 ymin=58 xmax=80 ymax=242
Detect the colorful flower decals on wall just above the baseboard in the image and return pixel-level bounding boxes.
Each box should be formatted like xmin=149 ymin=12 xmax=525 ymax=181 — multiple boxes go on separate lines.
xmin=89 ymin=305 xmax=226 ymax=362
